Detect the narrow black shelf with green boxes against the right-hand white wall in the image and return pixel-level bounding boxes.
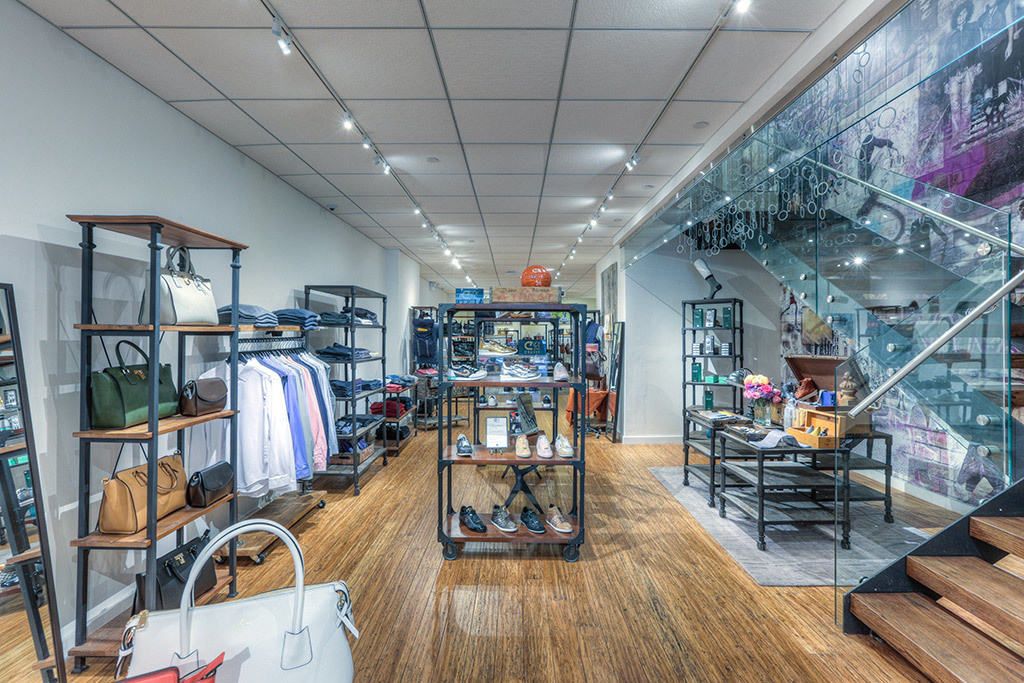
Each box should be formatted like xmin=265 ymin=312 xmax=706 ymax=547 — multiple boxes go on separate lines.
xmin=682 ymin=299 xmax=743 ymax=420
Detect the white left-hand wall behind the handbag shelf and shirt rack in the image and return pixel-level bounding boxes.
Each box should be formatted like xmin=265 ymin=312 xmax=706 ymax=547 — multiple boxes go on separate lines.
xmin=0 ymin=0 xmax=436 ymax=645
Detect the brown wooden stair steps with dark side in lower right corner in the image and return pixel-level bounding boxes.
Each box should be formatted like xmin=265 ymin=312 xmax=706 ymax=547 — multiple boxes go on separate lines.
xmin=843 ymin=482 xmax=1024 ymax=683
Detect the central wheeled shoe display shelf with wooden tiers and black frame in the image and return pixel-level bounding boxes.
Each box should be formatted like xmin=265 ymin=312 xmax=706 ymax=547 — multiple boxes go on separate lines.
xmin=437 ymin=303 xmax=587 ymax=562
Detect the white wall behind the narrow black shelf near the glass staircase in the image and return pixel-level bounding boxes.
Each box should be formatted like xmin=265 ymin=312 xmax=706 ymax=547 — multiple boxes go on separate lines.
xmin=620 ymin=244 xmax=780 ymax=443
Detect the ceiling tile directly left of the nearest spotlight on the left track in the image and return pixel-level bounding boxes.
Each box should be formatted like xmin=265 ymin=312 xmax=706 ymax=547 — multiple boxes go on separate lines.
xmin=153 ymin=29 xmax=330 ymax=98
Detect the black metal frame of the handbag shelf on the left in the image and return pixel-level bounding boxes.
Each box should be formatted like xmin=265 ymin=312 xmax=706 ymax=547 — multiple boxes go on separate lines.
xmin=72 ymin=222 xmax=244 ymax=673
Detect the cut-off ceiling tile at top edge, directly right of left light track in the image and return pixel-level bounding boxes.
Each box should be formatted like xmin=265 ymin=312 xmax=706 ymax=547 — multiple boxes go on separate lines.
xmin=273 ymin=0 xmax=423 ymax=28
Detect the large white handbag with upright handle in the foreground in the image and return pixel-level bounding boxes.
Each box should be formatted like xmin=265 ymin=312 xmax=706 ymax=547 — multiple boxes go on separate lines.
xmin=118 ymin=519 xmax=359 ymax=683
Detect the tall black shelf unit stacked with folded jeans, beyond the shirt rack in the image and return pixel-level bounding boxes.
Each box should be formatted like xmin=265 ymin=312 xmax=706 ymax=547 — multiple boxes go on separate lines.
xmin=303 ymin=285 xmax=388 ymax=496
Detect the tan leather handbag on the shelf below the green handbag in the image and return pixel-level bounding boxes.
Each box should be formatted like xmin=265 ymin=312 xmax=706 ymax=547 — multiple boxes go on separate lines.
xmin=99 ymin=452 xmax=188 ymax=533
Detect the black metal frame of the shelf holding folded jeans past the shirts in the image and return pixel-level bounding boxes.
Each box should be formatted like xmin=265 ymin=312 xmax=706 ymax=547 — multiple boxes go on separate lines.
xmin=303 ymin=285 xmax=387 ymax=496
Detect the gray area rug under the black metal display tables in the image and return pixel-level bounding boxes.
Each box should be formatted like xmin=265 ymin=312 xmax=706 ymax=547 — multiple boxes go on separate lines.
xmin=647 ymin=467 xmax=925 ymax=586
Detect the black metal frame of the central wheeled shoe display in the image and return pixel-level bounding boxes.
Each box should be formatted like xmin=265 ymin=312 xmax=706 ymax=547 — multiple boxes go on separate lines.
xmin=434 ymin=303 xmax=588 ymax=562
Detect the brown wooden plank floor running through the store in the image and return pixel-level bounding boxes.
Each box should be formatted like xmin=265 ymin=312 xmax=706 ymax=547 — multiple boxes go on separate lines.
xmin=0 ymin=409 xmax=924 ymax=683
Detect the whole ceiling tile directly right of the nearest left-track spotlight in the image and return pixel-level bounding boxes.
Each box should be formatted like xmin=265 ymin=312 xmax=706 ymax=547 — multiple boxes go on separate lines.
xmin=295 ymin=29 xmax=444 ymax=99
